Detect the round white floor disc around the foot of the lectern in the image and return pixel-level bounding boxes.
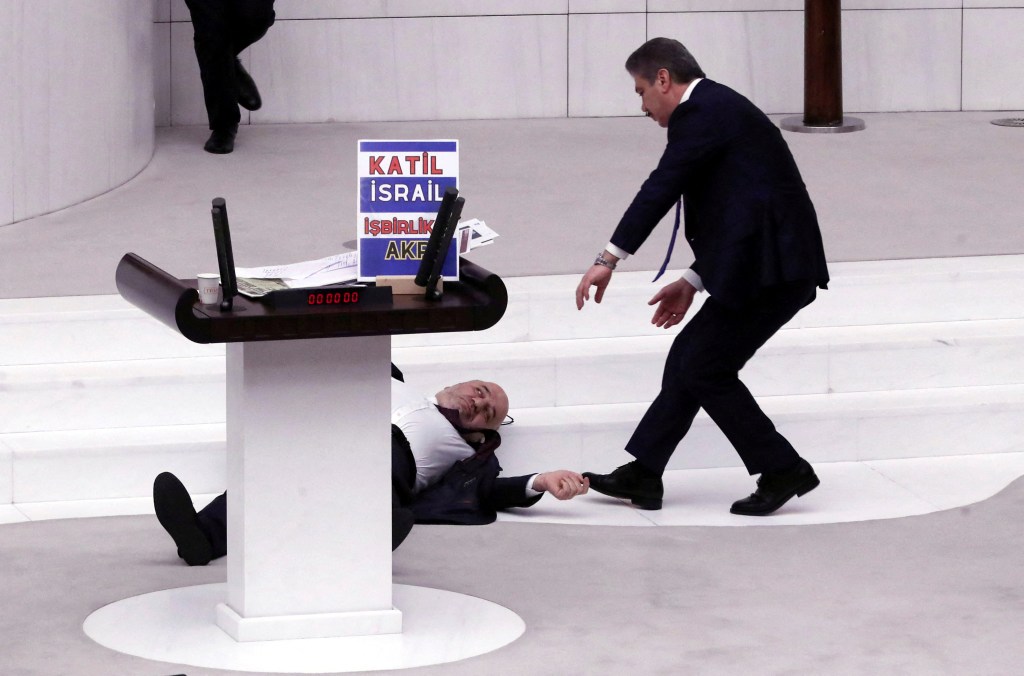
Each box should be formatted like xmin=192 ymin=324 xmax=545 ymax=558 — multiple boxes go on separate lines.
xmin=83 ymin=584 xmax=526 ymax=674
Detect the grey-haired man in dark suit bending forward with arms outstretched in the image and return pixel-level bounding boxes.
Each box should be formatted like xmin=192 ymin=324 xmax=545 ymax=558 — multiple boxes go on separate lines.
xmin=577 ymin=38 xmax=828 ymax=516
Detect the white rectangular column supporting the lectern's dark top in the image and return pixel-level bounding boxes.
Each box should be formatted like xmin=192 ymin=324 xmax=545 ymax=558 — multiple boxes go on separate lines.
xmin=216 ymin=336 xmax=401 ymax=641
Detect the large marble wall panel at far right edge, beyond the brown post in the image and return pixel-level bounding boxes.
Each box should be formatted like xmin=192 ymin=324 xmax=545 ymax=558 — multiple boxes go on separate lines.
xmin=963 ymin=8 xmax=1024 ymax=111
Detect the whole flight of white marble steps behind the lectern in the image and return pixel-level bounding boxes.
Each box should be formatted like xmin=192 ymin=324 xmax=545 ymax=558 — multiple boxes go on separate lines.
xmin=0 ymin=256 xmax=1024 ymax=504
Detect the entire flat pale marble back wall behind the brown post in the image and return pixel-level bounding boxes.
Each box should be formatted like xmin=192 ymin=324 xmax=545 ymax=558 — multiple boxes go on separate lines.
xmin=153 ymin=0 xmax=1024 ymax=122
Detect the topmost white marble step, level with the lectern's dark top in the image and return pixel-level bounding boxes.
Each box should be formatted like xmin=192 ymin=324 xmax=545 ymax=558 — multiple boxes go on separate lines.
xmin=0 ymin=256 xmax=1024 ymax=366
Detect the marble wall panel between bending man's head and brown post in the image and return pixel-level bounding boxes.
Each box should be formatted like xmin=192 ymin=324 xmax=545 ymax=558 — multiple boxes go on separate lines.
xmin=647 ymin=11 xmax=804 ymax=114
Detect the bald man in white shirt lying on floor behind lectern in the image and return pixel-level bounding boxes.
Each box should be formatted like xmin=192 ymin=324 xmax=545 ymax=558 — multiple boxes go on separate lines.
xmin=153 ymin=365 xmax=590 ymax=565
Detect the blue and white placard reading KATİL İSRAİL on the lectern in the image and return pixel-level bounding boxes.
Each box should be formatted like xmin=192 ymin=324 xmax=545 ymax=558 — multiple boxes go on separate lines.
xmin=357 ymin=140 xmax=459 ymax=282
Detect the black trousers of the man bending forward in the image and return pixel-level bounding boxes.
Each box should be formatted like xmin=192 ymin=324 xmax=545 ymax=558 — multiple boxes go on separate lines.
xmin=626 ymin=283 xmax=814 ymax=474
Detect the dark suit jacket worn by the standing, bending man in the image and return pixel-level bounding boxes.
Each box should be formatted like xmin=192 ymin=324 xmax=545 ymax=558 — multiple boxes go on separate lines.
xmin=611 ymin=80 xmax=828 ymax=305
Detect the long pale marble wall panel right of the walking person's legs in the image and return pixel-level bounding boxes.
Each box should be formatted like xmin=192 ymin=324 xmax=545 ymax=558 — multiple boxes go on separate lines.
xmin=251 ymin=15 xmax=568 ymax=122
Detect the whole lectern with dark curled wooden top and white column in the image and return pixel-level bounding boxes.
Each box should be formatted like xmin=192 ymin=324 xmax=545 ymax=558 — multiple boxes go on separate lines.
xmin=117 ymin=253 xmax=508 ymax=641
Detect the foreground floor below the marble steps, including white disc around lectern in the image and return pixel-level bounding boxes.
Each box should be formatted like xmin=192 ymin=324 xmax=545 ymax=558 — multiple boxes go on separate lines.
xmin=0 ymin=452 xmax=1024 ymax=676
